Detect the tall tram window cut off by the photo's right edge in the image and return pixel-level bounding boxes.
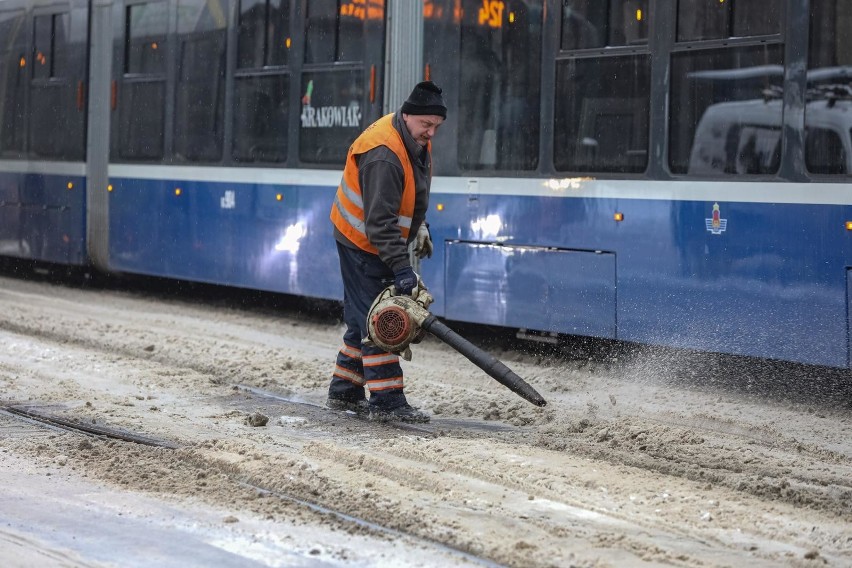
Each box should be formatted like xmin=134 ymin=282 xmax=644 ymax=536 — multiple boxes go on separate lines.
xmin=805 ymin=0 xmax=852 ymax=175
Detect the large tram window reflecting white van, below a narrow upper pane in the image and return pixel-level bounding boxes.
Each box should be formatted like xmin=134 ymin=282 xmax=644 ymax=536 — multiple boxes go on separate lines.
xmin=669 ymin=44 xmax=783 ymax=175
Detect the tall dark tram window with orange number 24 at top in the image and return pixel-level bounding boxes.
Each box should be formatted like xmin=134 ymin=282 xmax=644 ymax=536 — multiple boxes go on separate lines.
xmin=458 ymin=0 xmax=542 ymax=170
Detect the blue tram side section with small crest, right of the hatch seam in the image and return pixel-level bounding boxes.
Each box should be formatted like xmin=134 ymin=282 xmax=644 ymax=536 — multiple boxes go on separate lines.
xmin=618 ymin=195 xmax=847 ymax=367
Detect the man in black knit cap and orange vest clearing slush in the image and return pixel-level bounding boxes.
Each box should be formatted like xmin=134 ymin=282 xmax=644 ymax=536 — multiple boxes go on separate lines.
xmin=327 ymin=81 xmax=447 ymax=422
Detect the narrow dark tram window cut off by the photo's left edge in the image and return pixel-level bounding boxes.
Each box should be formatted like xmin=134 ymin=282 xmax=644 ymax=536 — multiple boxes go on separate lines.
xmin=0 ymin=12 xmax=29 ymax=153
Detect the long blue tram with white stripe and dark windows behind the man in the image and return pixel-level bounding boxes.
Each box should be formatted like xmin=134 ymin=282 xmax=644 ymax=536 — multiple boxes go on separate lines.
xmin=0 ymin=0 xmax=852 ymax=367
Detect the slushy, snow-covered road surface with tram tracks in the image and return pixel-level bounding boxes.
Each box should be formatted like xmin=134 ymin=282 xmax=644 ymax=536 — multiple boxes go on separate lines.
xmin=0 ymin=277 xmax=852 ymax=567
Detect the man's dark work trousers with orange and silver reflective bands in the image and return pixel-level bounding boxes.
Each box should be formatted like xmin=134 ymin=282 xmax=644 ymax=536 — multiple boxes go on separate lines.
xmin=328 ymin=243 xmax=406 ymax=409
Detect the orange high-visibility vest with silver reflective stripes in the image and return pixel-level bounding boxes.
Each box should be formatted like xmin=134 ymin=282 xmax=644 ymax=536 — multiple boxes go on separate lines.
xmin=331 ymin=113 xmax=432 ymax=254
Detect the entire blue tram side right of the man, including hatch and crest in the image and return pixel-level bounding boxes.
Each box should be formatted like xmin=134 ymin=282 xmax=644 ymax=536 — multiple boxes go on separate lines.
xmin=440 ymin=184 xmax=849 ymax=367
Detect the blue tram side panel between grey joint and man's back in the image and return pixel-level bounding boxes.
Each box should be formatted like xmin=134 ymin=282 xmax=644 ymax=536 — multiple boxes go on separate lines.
xmin=110 ymin=171 xmax=341 ymax=298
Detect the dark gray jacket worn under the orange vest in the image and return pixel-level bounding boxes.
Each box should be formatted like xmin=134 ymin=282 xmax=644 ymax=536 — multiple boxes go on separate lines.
xmin=334 ymin=111 xmax=432 ymax=272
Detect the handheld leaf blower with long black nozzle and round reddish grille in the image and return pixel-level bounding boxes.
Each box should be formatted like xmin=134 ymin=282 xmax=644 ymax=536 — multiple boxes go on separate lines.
xmin=364 ymin=282 xmax=547 ymax=406
